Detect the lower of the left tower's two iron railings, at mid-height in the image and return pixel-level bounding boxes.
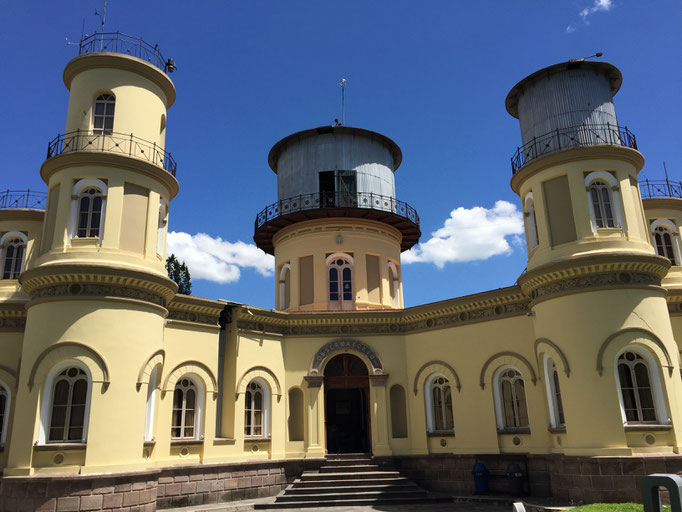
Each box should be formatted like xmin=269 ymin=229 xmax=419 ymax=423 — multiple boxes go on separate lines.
xmin=47 ymin=130 xmax=177 ymax=176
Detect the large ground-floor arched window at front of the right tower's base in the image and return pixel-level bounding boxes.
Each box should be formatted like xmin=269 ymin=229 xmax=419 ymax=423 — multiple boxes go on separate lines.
xmin=617 ymin=351 xmax=657 ymax=423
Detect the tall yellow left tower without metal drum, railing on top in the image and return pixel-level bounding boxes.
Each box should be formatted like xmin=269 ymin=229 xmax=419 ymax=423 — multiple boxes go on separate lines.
xmin=5 ymin=33 xmax=178 ymax=475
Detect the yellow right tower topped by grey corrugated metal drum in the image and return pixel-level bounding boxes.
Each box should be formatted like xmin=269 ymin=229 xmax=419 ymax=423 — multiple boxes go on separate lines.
xmin=506 ymin=60 xmax=682 ymax=455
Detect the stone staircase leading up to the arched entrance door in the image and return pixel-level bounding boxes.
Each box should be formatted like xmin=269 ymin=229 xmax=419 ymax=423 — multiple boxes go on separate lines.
xmin=255 ymin=453 xmax=452 ymax=509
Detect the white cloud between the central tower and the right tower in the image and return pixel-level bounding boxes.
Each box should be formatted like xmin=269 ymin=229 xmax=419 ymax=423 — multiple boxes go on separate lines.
xmin=402 ymin=201 xmax=524 ymax=268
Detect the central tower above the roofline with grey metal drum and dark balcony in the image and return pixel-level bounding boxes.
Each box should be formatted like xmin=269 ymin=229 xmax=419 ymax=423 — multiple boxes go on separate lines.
xmin=254 ymin=126 xmax=421 ymax=311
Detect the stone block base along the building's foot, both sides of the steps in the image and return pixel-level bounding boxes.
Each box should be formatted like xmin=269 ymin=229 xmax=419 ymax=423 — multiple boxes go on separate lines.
xmin=0 ymin=454 xmax=682 ymax=512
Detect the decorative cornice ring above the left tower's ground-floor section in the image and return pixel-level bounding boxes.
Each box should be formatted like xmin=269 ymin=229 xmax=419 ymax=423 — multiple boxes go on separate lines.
xmin=19 ymin=264 xmax=177 ymax=307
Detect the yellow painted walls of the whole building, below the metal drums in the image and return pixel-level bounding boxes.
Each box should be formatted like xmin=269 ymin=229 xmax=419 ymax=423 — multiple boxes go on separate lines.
xmin=0 ymin=44 xmax=682 ymax=492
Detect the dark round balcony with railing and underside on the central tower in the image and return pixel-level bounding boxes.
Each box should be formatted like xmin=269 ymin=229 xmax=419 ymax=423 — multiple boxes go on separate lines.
xmin=253 ymin=192 xmax=421 ymax=254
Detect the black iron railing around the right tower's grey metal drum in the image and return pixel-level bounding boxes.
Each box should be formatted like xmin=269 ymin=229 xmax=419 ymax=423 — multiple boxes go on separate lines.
xmin=511 ymin=123 xmax=637 ymax=174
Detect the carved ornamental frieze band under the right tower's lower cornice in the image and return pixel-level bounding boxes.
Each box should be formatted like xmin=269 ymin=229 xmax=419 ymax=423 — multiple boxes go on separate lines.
xmin=531 ymin=271 xmax=661 ymax=301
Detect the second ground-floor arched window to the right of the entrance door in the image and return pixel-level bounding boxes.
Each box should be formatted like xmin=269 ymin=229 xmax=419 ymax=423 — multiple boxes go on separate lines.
xmin=494 ymin=366 xmax=529 ymax=430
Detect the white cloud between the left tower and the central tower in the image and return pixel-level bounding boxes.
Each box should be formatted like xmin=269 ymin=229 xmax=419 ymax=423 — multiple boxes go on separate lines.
xmin=166 ymin=231 xmax=275 ymax=283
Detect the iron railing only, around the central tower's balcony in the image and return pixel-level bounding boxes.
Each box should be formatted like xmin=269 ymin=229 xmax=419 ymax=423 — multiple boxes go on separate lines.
xmin=256 ymin=192 xmax=419 ymax=229
